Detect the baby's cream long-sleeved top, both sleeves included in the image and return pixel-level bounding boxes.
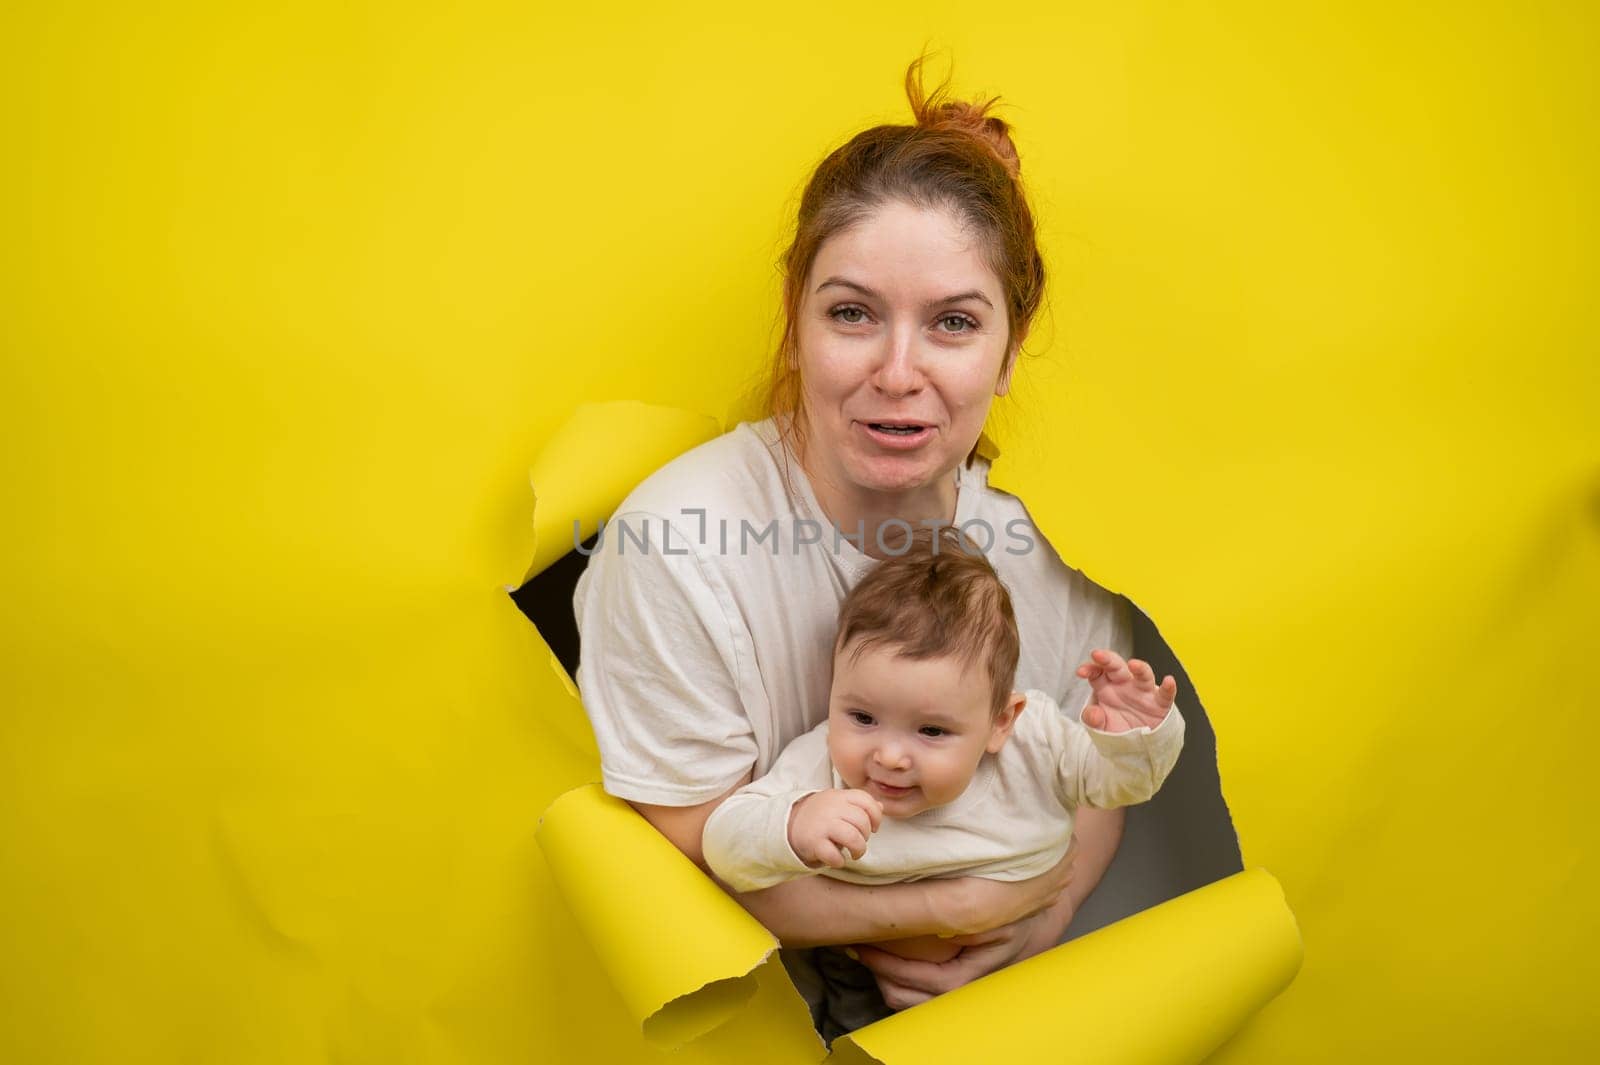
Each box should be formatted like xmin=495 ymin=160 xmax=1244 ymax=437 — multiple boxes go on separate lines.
xmin=704 ymin=691 xmax=1184 ymax=891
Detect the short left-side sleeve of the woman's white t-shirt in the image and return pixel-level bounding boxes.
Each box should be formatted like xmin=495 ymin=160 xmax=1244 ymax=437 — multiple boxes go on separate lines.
xmin=573 ymin=512 xmax=757 ymax=806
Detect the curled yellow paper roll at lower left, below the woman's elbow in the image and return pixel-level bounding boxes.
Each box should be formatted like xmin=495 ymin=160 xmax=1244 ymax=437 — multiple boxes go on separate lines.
xmin=538 ymin=784 xmax=778 ymax=1047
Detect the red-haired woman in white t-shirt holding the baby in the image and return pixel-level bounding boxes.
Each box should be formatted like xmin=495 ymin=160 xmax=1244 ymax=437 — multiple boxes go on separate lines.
xmin=574 ymin=59 xmax=1131 ymax=1009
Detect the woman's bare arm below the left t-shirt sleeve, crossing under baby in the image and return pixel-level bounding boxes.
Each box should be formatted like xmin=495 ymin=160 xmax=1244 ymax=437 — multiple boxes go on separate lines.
xmin=629 ymin=772 xmax=1072 ymax=947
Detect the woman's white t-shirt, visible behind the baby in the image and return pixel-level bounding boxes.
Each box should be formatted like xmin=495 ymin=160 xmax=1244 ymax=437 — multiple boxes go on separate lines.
xmin=573 ymin=419 xmax=1131 ymax=806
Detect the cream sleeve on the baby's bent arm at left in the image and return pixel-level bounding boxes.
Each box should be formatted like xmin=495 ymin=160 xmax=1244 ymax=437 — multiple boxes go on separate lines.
xmin=701 ymin=721 xmax=834 ymax=891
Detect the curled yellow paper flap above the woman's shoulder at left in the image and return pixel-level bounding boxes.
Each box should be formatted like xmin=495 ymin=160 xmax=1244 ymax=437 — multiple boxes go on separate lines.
xmin=523 ymin=400 xmax=720 ymax=580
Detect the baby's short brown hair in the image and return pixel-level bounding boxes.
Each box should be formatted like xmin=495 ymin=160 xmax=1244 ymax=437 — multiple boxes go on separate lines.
xmin=834 ymin=526 xmax=1021 ymax=715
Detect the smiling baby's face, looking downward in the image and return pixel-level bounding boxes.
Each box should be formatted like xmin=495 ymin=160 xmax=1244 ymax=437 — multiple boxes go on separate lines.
xmin=827 ymin=633 xmax=1010 ymax=817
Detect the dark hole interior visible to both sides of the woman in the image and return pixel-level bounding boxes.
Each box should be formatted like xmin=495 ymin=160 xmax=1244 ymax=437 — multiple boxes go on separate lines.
xmin=512 ymin=550 xmax=1243 ymax=939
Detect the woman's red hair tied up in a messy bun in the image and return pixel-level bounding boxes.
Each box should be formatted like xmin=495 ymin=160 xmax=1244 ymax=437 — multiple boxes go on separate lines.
xmin=766 ymin=56 xmax=1045 ymax=459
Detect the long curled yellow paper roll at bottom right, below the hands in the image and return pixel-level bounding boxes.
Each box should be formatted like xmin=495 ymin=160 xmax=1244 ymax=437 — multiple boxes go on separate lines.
xmin=829 ymin=868 xmax=1301 ymax=1065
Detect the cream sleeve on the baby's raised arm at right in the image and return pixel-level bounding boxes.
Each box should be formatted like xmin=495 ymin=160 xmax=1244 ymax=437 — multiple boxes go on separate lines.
xmin=1029 ymin=692 xmax=1184 ymax=809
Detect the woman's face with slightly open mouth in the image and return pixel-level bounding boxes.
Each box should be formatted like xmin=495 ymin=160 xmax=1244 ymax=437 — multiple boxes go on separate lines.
xmin=797 ymin=201 xmax=1011 ymax=494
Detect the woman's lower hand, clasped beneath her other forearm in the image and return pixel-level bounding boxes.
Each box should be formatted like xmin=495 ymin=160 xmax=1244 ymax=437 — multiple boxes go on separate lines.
xmin=853 ymin=895 xmax=1072 ymax=1009
